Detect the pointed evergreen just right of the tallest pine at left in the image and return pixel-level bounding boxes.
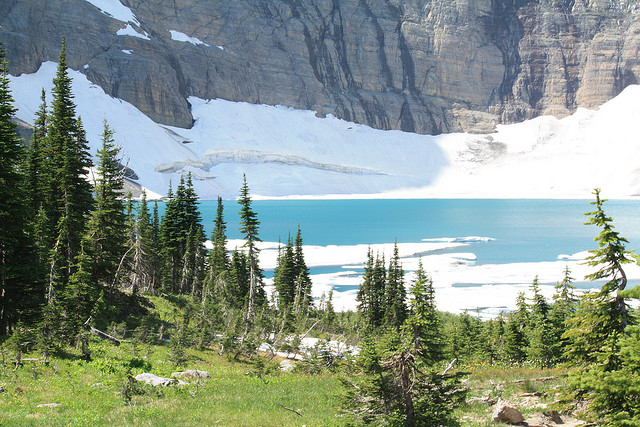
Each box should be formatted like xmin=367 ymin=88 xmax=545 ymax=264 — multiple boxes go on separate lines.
xmin=87 ymin=120 xmax=127 ymax=287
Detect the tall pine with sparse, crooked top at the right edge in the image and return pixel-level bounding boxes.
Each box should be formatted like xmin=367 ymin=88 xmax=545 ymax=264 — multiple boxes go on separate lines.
xmin=563 ymin=193 xmax=640 ymax=426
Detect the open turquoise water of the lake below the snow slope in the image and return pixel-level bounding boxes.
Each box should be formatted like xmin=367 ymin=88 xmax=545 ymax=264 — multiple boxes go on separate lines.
xmin=200 ymin=199 xmax=640 ymax=265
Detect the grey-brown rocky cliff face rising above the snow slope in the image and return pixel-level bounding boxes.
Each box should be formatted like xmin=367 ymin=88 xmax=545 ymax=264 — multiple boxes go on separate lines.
xmin=0 ymin=0 xmax=640 ymax=134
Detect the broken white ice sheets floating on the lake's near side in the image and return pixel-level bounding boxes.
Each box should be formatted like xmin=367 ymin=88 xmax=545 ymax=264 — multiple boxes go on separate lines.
xmin=219 ymin=237 xmax=640 ymax=319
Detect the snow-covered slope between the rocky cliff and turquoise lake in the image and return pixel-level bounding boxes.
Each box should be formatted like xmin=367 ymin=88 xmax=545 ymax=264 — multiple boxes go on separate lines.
xmin=11 ymin=62 xmax=640 ymax=199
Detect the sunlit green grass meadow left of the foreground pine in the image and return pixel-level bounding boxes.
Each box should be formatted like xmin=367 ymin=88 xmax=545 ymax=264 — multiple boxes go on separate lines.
xmin=0 ymin=341 xmax=343 ymax=426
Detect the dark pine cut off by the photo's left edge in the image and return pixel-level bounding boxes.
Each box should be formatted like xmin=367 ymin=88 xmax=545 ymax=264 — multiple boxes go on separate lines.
xmin=0 ymin=45 xmax=41 ymax=337
